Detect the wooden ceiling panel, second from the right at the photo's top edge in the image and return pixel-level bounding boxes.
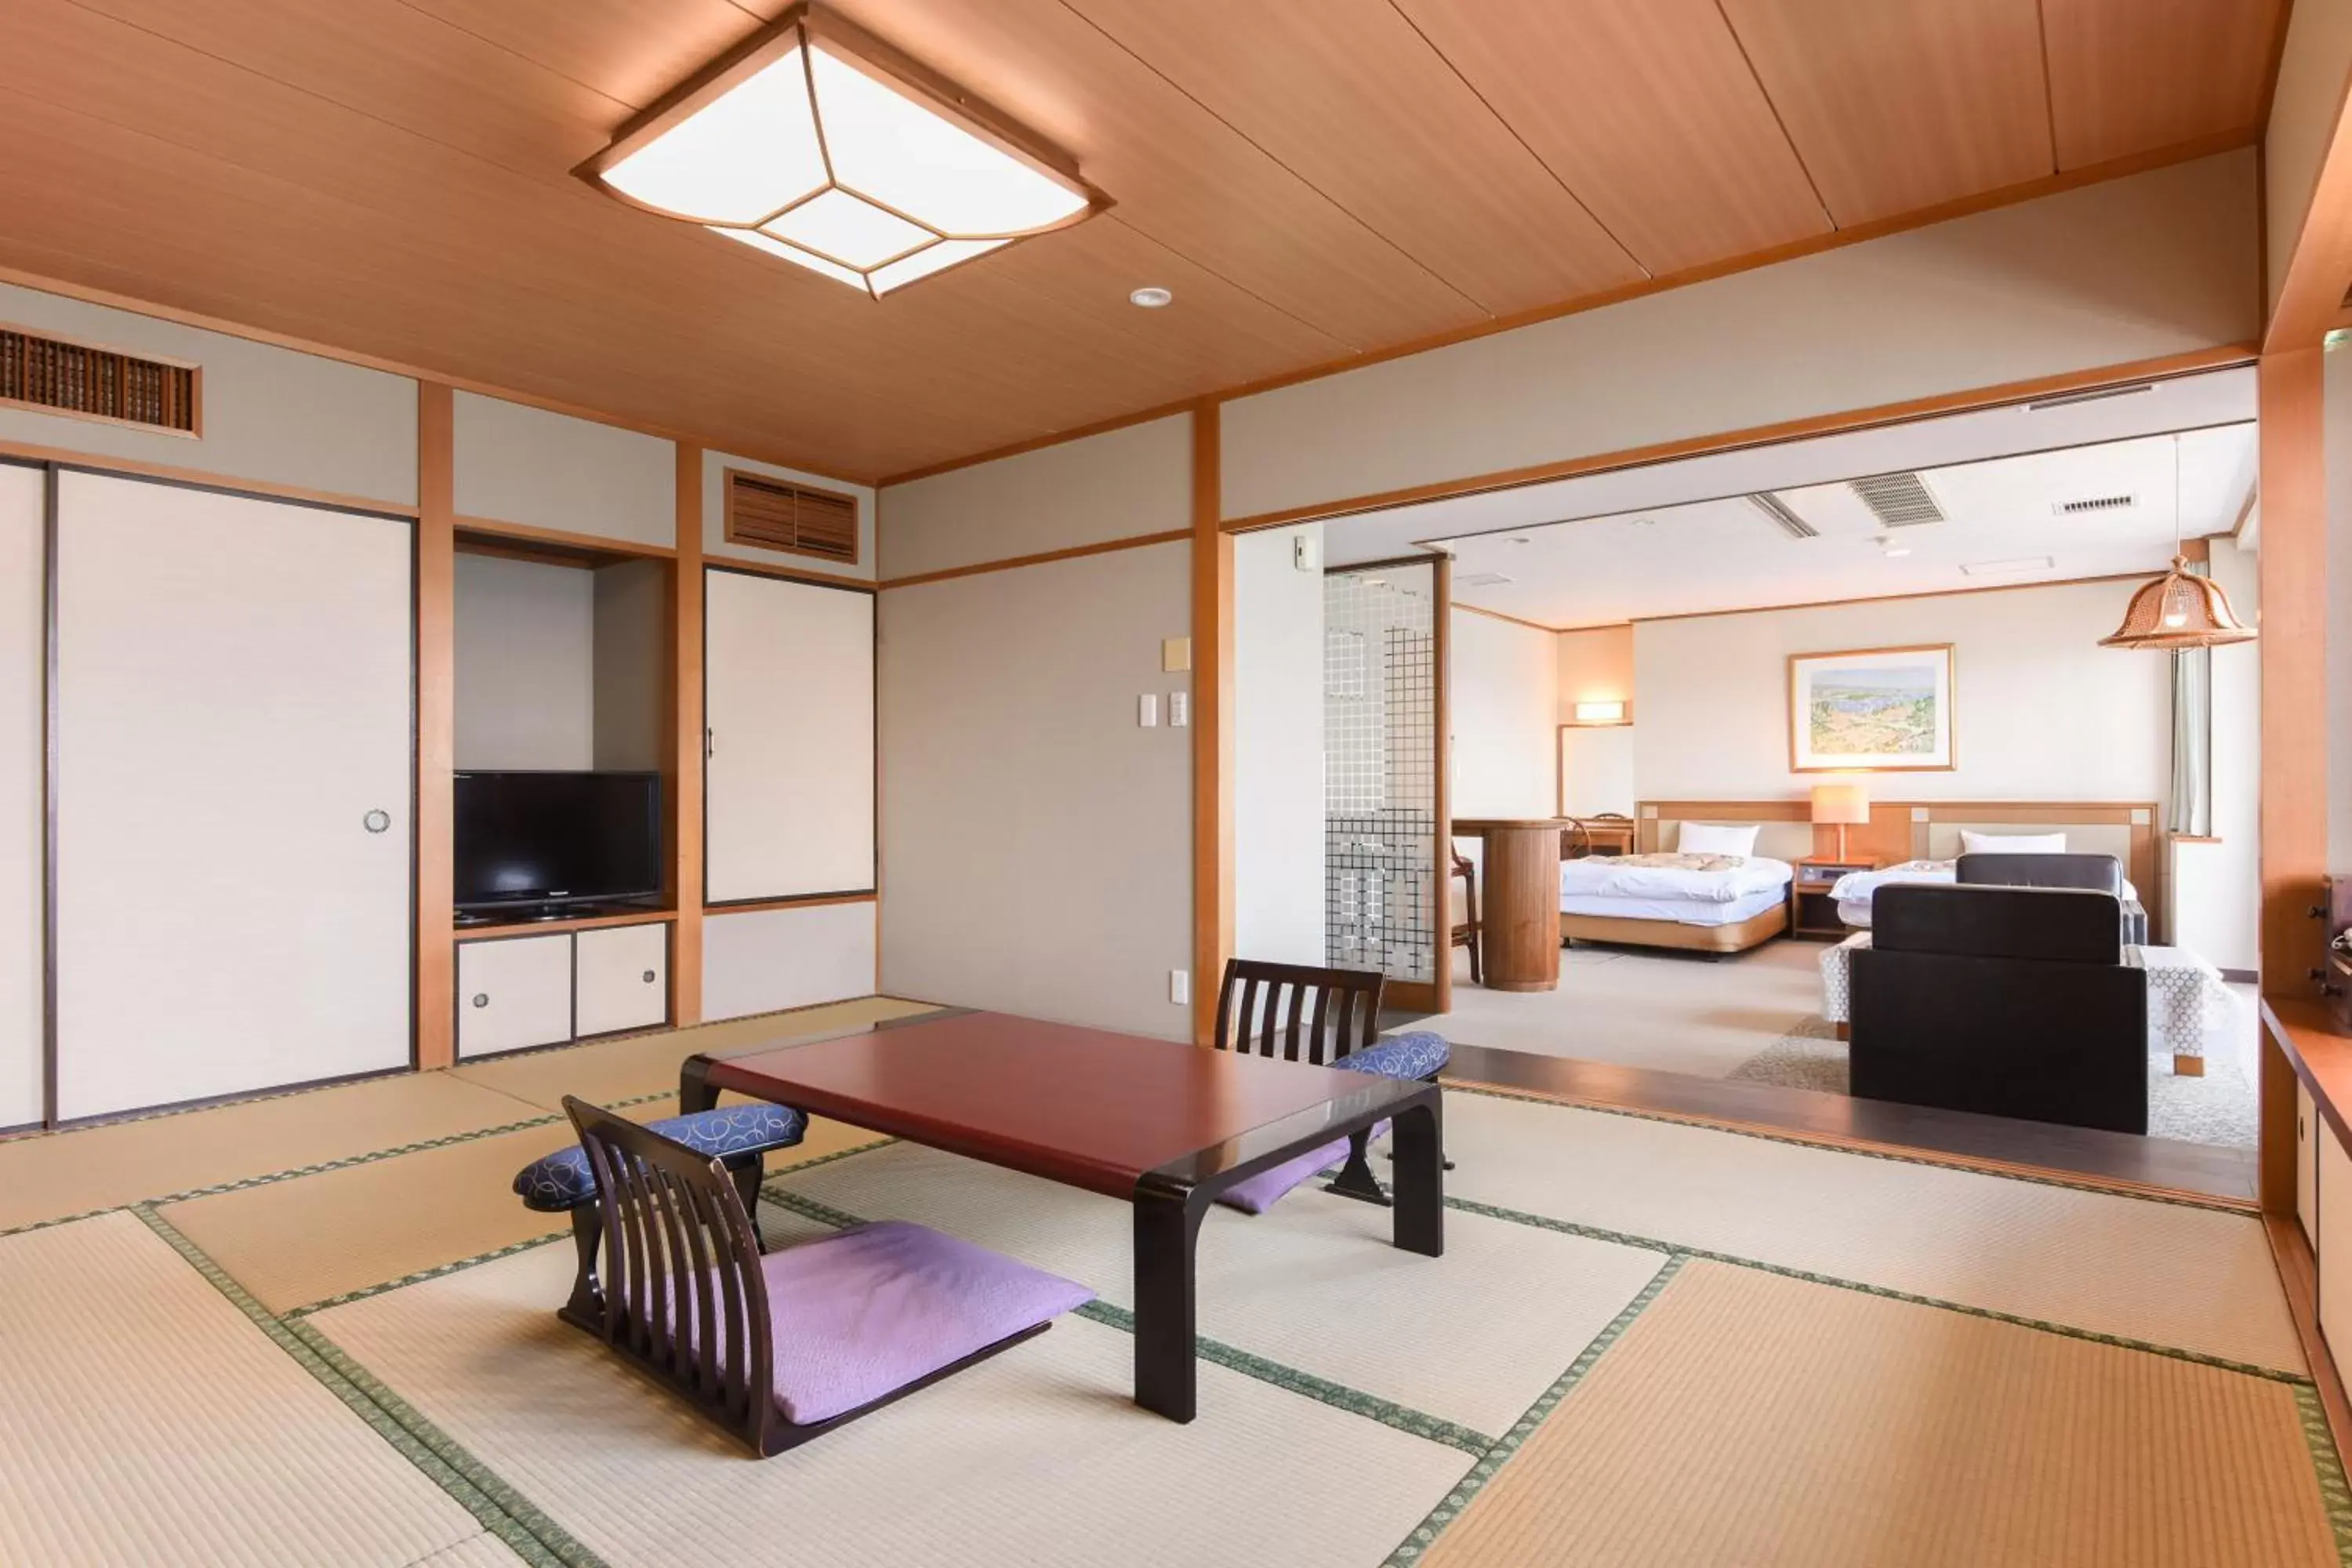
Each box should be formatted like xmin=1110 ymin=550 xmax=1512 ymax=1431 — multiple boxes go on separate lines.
xmin=1722 ymin=0 xmax=2056 ymax=228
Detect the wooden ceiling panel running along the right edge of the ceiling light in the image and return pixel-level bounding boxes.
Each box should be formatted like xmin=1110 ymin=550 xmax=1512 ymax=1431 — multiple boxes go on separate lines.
xmin=818 ymin=0 xmax=1484 ymax=348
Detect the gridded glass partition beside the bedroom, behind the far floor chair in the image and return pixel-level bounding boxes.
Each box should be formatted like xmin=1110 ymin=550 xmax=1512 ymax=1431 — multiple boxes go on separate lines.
xmin=1324 ymin=564 xmax=1442 ymax=985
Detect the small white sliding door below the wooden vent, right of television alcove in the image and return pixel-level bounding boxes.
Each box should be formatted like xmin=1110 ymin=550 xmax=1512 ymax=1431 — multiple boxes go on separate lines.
xmin=703 ymin=572 xmax=875 ymax=902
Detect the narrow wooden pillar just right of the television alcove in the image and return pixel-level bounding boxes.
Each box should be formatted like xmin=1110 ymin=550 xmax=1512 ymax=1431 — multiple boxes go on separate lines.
xmin=661 ymin=442 xmax=703 ymax=1027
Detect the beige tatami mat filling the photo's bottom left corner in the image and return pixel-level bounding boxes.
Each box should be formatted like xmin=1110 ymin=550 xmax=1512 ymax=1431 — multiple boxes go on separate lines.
xmin=0 ymin=1213 xmax=496 ymax=1568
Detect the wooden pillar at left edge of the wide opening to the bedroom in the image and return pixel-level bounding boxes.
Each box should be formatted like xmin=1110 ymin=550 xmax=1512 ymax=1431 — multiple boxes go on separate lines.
xmin=1192 ymin=402 xmax=1232 ymax=1046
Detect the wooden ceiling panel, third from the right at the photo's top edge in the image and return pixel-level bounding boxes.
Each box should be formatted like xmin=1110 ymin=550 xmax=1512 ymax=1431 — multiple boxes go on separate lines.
xmin=1397 ymin=0 xmax=1830 ymax=273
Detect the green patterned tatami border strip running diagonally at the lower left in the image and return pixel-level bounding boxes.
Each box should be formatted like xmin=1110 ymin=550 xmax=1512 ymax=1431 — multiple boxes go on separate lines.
xmin=129 ymin=1203 xmax=602 ymax=1568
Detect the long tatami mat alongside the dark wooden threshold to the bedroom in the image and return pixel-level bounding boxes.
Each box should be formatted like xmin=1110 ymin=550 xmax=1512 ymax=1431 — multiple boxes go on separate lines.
xmin=1446 ymin=1093 xmax=2305 ymax=1370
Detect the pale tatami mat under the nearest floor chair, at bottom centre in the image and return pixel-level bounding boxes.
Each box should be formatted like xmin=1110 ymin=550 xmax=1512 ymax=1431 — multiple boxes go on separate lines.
xmin=310 ymin=1248 xmax=1470 ymax=1568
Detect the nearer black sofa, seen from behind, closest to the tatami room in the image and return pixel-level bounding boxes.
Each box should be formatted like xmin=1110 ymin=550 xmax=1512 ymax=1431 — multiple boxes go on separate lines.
xmin=1851 ymin=888 xmax=2147 ymax=1133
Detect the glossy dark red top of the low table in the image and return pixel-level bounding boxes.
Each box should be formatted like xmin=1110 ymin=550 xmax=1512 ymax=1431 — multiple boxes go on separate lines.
xmin=687 ymin=1013 xmax=1418 ymax=1199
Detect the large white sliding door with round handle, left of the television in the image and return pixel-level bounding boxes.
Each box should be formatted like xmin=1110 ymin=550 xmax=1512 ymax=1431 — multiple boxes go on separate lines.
xmin=56 ymin=473 xmax=412 ymax=1119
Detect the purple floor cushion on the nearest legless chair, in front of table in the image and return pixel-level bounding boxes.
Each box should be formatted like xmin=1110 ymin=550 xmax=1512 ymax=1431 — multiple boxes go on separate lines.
xmin=760 ymin=1220 xmax=1094 ymax=1427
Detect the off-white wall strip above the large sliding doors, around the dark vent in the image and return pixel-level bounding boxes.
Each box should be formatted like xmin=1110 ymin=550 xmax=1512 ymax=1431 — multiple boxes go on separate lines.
xmin=0 ymin=285 xmax=416 ymax=506
